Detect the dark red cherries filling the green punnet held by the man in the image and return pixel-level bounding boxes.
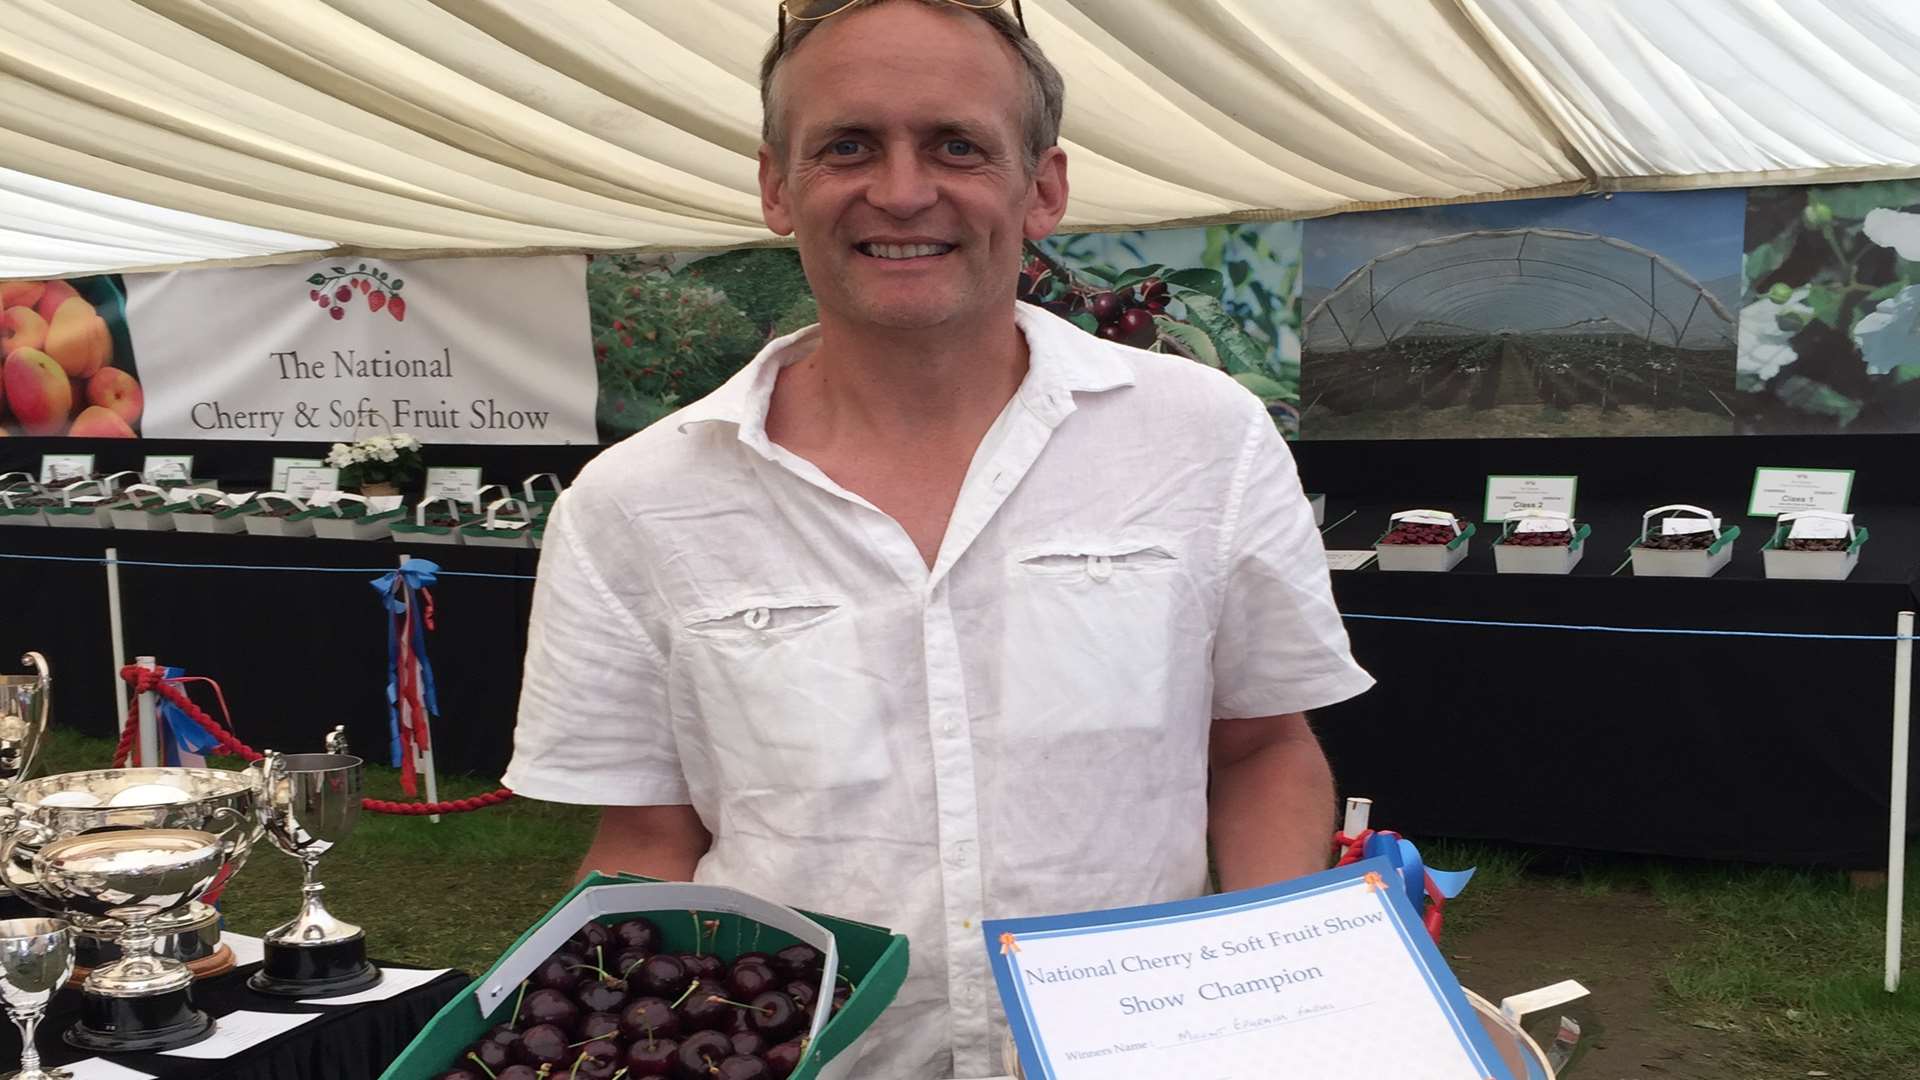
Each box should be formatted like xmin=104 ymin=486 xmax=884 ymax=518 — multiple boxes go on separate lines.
xmin=434 ymin=919 xmax=852 ymax=1080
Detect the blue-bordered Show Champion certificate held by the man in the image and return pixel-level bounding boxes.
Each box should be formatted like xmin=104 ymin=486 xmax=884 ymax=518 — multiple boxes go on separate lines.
xmin=983 ymin=859 xmax=1515 ymax=1080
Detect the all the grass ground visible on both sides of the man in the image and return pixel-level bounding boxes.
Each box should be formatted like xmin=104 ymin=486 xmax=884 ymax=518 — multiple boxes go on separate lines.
xmin=18 ymin=732 xmax=1920 ymax=1076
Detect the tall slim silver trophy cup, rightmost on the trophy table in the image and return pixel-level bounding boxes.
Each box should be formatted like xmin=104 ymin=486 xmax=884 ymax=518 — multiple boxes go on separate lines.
xmin=248 ymin=753 xmax=380 ymax=997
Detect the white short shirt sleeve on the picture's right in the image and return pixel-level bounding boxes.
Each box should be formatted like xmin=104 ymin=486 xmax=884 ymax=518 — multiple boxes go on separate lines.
xmin=1213 ymin=413 xmax=1373 ymax=719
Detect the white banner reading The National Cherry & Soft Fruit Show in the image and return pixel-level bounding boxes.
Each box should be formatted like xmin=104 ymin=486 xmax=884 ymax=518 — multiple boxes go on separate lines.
xmin=125 ymin=256 xmax=597 ymax=444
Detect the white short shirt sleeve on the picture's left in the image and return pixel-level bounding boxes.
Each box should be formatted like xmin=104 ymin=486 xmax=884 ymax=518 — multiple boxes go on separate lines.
xmin=501 ymin=488 xmax=689 ymax=805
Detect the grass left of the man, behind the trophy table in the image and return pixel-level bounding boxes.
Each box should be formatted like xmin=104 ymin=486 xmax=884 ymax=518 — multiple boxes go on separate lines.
xmin=35 ymin=732 xmax=599 ymax=974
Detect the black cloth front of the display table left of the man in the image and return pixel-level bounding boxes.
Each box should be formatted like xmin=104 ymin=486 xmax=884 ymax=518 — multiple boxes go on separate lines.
xmin=0 ymin=527 xmax=540 ymax=774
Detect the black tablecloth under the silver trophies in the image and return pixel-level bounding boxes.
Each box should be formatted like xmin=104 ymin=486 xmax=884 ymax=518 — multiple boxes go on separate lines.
xmin=0 ymin=965 xmax=470 ymax=1080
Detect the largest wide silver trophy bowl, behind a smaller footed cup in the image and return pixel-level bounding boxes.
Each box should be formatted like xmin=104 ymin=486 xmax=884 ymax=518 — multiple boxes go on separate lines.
xmin=0 ymin=769 xmax=261 ymax=976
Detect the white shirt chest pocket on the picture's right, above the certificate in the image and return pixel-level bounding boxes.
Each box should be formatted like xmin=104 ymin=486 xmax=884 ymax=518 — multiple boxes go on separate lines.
xmin=1000 ymin=540 xmax=1204 ymax=738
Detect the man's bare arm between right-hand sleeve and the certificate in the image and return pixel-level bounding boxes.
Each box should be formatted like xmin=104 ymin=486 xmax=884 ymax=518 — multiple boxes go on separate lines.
xmin=1208 ymin=713 xmax=1334 ymax=892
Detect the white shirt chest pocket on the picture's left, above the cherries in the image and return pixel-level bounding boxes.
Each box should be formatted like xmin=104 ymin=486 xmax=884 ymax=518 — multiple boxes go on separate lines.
xmin=680 ymin=596 xmax=889 ymax=796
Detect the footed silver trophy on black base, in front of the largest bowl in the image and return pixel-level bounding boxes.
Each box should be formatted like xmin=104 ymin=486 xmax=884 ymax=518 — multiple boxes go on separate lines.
xmin=33 ymin=828 xmax=232 ymax=1053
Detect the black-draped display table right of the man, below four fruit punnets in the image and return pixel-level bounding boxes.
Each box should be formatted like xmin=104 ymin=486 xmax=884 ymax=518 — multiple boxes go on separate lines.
xmin=1315 ymin=498 xmax=1920 ymax=867
